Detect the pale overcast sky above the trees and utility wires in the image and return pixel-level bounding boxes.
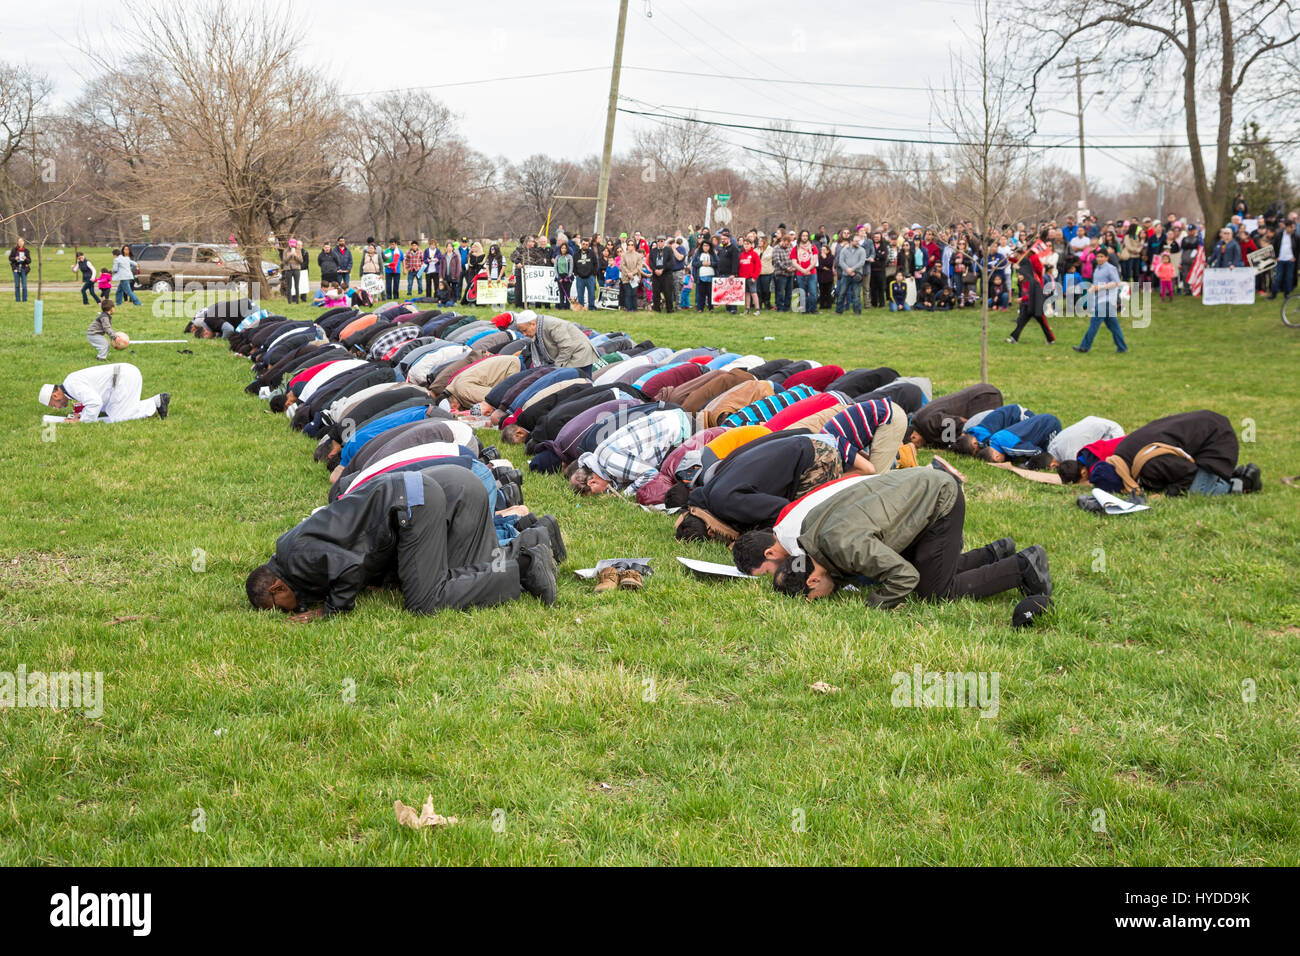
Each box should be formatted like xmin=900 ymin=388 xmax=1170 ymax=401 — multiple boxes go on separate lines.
xmin=0 ymin=0 xmax=1227 ymax=195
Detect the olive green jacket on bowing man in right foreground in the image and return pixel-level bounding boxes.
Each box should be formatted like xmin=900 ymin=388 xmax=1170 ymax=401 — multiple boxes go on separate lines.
xmin=798 ymin=468 xmax=961 ymax=607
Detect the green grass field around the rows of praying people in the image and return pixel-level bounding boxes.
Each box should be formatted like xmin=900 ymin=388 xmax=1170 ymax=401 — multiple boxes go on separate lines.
xmin=0 ymin=286 xmax=1300 ymax=865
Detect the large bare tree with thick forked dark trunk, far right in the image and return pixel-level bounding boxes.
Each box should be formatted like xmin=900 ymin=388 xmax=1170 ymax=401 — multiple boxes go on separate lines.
xmin=1023 ymin=0 xmax=1300 ymax=228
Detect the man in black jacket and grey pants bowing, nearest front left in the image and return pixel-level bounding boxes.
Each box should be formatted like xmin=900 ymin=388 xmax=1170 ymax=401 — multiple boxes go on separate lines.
xmin=244 ymin=466 xmax=558 ymax=620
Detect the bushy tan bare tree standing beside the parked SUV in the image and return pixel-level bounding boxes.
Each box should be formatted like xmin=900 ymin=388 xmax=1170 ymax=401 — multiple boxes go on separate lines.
xmin=86 ymin=0 xmax=341 ymax=294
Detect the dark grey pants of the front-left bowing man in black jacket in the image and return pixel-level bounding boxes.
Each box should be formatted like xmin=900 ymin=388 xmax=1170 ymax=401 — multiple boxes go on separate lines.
xmin=398 ymin=464 xmax=520 ymax=614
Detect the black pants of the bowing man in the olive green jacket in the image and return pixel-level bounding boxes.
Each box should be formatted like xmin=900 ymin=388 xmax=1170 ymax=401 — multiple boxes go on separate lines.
xmin=902 ymin=489 xmax=1021 ymax=601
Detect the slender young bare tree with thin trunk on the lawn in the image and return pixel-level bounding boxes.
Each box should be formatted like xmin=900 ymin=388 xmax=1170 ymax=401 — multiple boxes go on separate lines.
xmin=932 ymin=0 xmax=1028 ymax=381
